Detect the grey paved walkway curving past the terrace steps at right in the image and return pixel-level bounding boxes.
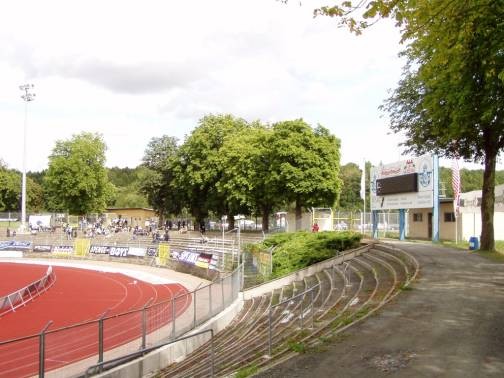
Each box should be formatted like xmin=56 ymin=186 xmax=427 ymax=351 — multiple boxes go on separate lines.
xmin=258 ymin=243 xmax=504 ymax=378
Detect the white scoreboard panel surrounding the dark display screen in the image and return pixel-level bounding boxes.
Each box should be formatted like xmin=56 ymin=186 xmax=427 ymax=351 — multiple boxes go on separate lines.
xmin=370 ymin=155 xmax=434 ymax=210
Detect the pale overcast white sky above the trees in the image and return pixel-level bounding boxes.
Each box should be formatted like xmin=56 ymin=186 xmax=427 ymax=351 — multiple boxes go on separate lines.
xmin=0 ymin=0 xmax=496 ymax=171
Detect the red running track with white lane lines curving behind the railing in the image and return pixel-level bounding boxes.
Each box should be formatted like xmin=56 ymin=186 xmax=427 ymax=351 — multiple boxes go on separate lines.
xmin=0 ymin=263 xmax=191 ymax=378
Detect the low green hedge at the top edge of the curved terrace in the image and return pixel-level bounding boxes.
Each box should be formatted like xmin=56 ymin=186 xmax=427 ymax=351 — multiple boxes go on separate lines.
xmin=254 ymin=231 xmax=362 ymax=277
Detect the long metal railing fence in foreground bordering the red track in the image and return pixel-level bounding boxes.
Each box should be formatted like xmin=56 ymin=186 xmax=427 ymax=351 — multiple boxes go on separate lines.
xmin=0 ymin=266 xmax=242 ymax=377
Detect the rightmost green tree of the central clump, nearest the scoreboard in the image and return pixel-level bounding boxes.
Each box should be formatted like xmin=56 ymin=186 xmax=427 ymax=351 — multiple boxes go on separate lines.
xmin=270 ymin=119 xmax=341 ymax=230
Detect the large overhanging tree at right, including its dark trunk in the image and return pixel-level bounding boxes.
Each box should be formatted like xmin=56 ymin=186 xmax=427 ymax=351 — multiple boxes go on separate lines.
xmin=315 ymin=0 xmax=504 ymax=250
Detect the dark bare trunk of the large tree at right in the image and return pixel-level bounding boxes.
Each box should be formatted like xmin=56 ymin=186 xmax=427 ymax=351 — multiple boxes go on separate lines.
xmin=480 ymin=149 xmax=497 ymax=251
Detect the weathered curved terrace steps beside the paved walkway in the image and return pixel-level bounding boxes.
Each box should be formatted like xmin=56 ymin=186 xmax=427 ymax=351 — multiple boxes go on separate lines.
xmin=157 ymin=246 xmax=418 ymax=377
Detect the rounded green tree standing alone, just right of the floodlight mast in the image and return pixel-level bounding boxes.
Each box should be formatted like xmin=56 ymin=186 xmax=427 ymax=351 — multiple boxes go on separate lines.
xmin=44 ymin=132 xmax=115 ymax=215
